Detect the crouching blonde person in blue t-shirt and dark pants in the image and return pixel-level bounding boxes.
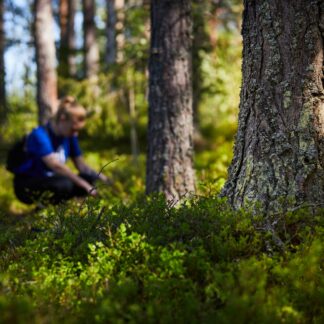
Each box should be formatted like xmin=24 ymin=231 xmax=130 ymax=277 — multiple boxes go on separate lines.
xmin=14 ymin=96 xmax=107 ymax=204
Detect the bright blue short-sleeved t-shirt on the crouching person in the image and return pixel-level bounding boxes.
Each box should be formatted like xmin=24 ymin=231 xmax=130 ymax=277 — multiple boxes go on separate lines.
xmin=17 ymin=124 xmax=81 ymax=177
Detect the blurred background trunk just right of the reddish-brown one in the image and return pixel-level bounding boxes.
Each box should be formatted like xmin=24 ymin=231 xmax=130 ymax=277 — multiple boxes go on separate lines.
xmin=82 ymin=0 xmax=99 ymax=80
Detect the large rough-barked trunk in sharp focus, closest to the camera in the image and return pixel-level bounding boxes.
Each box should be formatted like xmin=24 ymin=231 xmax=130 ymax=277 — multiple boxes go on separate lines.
xmin=223 ymin=0 xmax=324 ymax=211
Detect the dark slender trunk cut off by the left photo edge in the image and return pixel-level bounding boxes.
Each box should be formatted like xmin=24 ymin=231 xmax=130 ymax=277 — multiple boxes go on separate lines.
xmin=0 ymin=0 xmax=7 ymax=124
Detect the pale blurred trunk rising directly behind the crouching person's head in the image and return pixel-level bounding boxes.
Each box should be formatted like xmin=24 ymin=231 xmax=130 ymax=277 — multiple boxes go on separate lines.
xmin=34 ymin=0 xmax=57 ymax=125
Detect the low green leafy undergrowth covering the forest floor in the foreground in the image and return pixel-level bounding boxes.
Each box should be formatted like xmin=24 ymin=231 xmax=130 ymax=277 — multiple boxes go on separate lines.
xmin=0 ymin=196 xmax=324 ymax=323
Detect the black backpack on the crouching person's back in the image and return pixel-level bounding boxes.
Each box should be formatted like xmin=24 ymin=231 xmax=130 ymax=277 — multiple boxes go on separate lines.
xmin=6 ymin=135 xmax=28 ymax=173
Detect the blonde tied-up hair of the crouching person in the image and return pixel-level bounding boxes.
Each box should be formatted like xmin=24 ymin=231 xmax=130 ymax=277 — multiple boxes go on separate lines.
xmin=54 ymin=96 xmax=87 ymax=122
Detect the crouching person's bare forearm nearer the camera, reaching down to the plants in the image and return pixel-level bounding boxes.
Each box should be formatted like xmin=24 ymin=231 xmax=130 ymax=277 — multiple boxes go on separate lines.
xmin=42 ymin=153 xmax=97 ymax=196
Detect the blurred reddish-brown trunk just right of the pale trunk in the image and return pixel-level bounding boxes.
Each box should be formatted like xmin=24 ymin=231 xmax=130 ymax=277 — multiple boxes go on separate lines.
xmin=59 ymin=0 xmax=77 ymax=77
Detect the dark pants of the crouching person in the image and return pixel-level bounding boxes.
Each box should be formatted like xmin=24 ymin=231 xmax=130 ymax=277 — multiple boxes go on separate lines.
xmin=14 ymin=173 xmax=97 ymax=204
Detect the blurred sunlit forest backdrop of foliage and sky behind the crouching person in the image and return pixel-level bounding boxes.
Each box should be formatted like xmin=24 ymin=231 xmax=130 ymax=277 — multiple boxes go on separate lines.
xmin=0 ymin=0 xmax=243 ymax=210
